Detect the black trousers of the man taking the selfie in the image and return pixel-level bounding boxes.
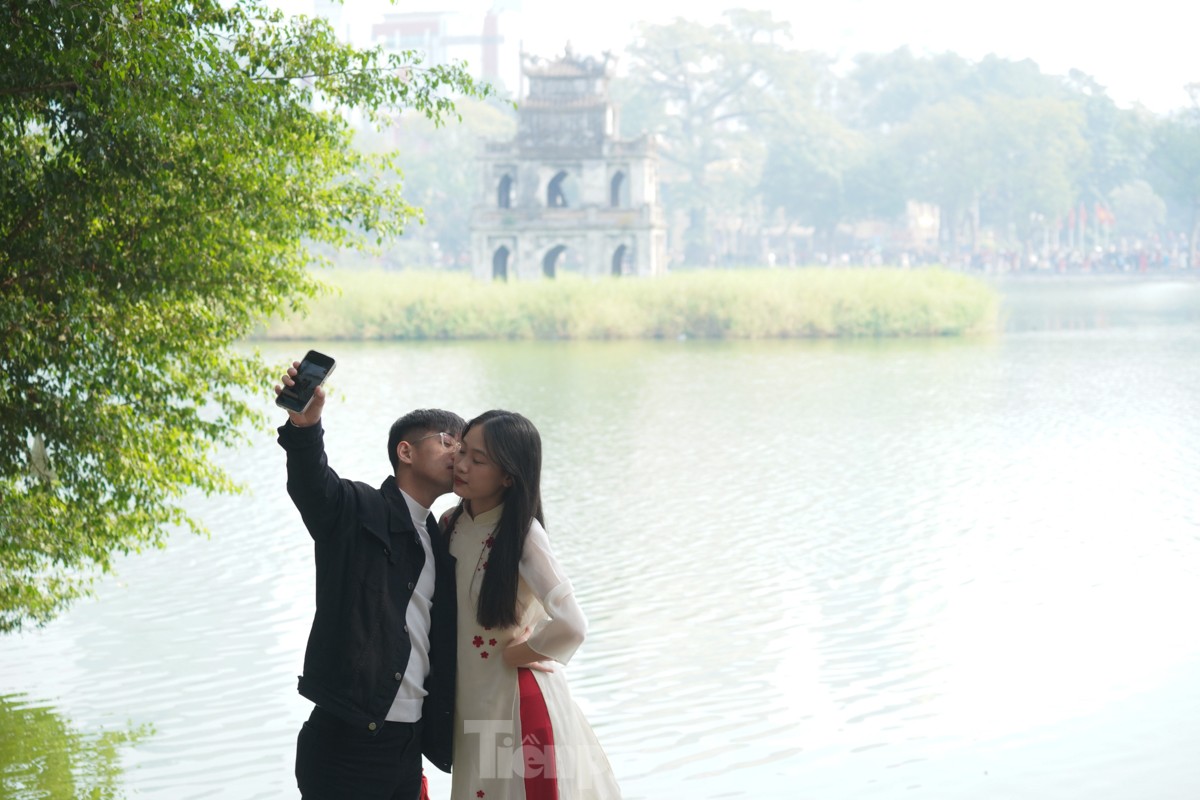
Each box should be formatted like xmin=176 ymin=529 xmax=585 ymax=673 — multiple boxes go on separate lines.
xmin=296 ymin=705 xmax=421 ymax=800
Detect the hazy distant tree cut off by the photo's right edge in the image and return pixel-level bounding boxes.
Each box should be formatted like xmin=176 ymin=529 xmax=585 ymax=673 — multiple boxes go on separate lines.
xmin=1150 ymin=84 xmax=1200 ymax=267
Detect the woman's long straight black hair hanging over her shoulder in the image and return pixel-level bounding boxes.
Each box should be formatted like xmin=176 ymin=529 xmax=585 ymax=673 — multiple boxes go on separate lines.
xmin=448 ymin=409 xmax=545 ymax=628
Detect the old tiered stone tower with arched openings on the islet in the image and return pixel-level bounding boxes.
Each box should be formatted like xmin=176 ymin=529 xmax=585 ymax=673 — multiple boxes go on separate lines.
xmin=470 ymin=47 xmax=666 ymax=279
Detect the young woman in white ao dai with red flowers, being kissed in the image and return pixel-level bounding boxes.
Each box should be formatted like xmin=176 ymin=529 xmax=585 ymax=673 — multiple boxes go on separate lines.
xmin=442 ymin=410 xmax=620 ymax=800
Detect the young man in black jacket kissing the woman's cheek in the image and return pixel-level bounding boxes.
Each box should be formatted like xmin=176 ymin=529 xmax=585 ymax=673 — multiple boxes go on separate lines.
xmin=275 ymin=362 xmax=463 ymax=800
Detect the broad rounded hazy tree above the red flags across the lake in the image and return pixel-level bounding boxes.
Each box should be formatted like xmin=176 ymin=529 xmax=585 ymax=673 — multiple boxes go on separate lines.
xmin=846 ymin=50 xmax=1123 ymax=251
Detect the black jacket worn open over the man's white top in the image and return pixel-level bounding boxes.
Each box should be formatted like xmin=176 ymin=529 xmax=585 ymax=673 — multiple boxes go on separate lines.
xmin=278 ymin=422 xmax=456 ymax=771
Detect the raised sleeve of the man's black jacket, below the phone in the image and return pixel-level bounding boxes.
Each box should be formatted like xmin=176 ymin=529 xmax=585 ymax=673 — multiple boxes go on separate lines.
xmin=278 ymin=422 xmax=355 ymax=539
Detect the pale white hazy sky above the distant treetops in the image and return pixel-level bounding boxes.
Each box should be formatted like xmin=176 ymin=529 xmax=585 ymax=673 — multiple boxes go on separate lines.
xmin=288 ymin=0 xmax=1200 ymax=112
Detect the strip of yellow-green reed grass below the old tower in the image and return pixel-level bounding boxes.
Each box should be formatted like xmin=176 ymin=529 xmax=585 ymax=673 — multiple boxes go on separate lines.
xmin=257 ymin=267 xmax=1000 ymax=339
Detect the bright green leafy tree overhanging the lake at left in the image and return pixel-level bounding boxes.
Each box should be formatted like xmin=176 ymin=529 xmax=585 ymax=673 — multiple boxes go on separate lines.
xmin=0 ymin=0 xmax=488 ymax=631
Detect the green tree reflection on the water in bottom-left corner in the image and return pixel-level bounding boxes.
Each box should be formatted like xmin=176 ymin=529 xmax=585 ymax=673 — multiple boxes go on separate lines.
xmin=0 ymin=694 xmax=152 ymax=800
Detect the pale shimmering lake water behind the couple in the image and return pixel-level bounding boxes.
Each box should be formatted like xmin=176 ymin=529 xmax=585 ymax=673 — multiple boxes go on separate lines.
xmin=0 ymin=278 xmax=1200 ymax=800
